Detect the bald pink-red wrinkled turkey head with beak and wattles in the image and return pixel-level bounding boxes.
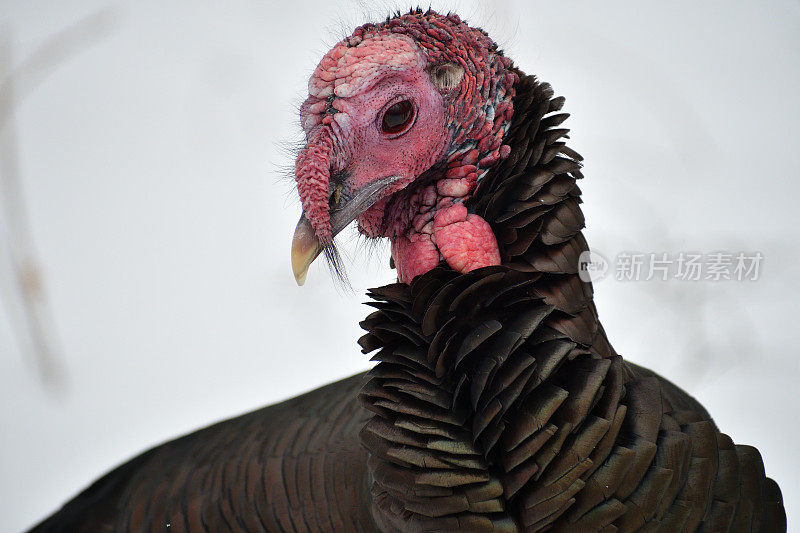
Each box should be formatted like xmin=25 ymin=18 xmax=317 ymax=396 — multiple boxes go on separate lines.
xmin=292 ymin=11 xmax=517 ymax=284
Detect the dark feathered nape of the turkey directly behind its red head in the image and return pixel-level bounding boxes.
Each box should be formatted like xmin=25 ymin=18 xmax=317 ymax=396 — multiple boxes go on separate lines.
xmin=468 ymin=71 xmax=614 ymax=356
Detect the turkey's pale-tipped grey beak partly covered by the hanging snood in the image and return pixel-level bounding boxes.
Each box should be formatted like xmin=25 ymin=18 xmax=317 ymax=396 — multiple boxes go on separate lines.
xmin=292 ymin=176 xmax=402 ymax=286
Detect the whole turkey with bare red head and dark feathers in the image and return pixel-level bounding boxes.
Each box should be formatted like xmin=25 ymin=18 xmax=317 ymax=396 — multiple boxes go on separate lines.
xmin=32 ymin=10 xmax=786 ymax=532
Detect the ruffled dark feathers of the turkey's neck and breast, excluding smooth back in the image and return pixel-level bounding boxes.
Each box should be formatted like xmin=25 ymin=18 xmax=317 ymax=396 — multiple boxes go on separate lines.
xmin=360 ymin=74 xmax=786 ymax=532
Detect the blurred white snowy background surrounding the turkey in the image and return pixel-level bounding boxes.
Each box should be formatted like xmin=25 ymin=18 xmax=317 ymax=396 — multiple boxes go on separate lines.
xmin=0 ymin=0 xmax=800 ymax=532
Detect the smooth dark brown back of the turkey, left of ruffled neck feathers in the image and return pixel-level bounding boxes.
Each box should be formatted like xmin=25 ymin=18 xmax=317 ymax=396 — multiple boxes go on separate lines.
xmin=32 ymin=375 xmax=376 ymax=533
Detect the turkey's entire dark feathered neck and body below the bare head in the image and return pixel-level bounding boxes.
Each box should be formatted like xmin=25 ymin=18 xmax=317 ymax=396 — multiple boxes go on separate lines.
xmin=28 ymin=31 xmax=786 ymax=533
